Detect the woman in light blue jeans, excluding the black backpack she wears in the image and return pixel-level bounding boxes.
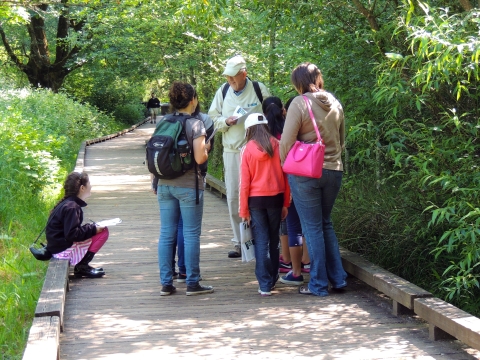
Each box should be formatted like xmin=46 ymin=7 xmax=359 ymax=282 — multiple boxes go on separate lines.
xmin=157 ymin=82 xmax=214 ymax=296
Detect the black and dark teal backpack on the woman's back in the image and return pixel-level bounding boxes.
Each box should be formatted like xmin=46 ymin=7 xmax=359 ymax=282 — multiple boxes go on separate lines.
xmin=146 ymin=113 xmax=195 ymax=179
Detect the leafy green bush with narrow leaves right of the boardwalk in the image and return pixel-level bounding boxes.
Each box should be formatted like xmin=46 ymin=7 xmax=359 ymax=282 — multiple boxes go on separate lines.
xmin=342 ymin=3 xmax=480 ymax=314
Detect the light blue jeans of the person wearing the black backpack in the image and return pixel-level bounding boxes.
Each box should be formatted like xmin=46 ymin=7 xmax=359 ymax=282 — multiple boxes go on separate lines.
xmin=157 ymin=185 xmax=203 ymax=286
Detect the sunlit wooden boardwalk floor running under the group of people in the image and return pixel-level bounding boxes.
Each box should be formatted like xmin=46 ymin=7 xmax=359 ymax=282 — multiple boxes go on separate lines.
xmin=60 ymin=124 xmax=480 ymax=360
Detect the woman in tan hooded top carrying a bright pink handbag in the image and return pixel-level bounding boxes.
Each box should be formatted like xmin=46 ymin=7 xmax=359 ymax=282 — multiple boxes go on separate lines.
xmin=280 ymin=62 xmax=347 ymax=296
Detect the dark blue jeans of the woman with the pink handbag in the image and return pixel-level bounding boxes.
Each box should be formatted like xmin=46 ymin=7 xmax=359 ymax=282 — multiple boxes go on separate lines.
xmin=288 ymin=169 xmax=347 ymax=296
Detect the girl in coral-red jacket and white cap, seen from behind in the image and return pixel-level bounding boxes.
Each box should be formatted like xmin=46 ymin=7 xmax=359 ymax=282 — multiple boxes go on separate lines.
xmin=239 ymin=113 xmax=290 ymax=296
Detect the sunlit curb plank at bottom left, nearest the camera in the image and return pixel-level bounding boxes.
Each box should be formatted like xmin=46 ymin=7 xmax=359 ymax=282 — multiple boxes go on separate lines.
xmin=23 ymin=316 xmax=60 ymax=360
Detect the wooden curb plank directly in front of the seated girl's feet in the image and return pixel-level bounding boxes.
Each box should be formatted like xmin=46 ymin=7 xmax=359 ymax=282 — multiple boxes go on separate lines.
xmin=35 ymin=258 xmax=69 ymax=331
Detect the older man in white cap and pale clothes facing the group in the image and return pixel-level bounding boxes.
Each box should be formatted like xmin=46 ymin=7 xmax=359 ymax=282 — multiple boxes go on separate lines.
xmin=208 ymin=55 xmax=270 ymax=258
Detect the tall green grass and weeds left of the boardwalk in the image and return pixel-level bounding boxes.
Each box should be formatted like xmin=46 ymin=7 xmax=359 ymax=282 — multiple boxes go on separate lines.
xmin=0 ymin=89 xmax=121 ymax=359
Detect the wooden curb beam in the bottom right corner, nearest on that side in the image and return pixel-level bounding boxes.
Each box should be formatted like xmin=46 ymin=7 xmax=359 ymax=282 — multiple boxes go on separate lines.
xmin=414 ymin=298 xmax=480 ymax=350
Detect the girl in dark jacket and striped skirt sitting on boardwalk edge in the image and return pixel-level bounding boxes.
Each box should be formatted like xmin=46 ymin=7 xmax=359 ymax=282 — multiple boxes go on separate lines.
xmin=45 ymin=172 xmax=108 ymax=278
